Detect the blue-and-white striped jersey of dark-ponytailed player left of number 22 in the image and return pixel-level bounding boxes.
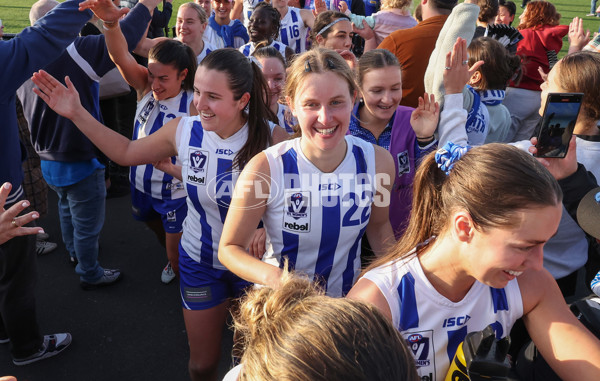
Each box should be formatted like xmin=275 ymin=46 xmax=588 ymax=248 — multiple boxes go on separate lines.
xmin=177 ymin=117 xmax=248 ymax=270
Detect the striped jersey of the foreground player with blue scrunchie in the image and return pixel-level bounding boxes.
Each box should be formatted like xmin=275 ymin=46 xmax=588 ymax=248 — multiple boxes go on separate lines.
xmin=364 ymin=255 xmax=523 ymax=381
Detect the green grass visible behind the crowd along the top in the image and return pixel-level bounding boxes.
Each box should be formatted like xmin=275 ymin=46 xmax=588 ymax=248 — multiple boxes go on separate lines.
xmin=0 ymin=0 xmax=600 ymax=57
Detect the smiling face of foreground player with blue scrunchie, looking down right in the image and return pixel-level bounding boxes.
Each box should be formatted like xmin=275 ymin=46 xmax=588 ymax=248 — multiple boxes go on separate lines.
xmin=464 ymin=204 xmax=562 ymax=288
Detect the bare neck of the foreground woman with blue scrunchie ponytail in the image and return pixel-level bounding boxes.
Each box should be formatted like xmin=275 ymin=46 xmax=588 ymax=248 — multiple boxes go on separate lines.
xmin=419 ymin=234 xmax=475 ymax=303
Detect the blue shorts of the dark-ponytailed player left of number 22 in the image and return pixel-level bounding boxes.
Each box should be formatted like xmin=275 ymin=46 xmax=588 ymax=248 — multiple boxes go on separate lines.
xmin=179 ymin=243 xmax=252 ymax=311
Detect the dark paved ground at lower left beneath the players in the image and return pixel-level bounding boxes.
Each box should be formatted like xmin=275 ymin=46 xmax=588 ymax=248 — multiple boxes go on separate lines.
xmin=0 ymin=191 xmax=231 ymax=381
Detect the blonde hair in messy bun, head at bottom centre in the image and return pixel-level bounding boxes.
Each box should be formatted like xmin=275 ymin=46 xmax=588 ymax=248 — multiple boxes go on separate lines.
xmin=234 ymin=272 xmax=419 ymax=381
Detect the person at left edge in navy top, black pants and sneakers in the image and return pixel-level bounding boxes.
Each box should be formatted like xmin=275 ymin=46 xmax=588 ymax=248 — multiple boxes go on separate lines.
xmin=0 ymin=0 xmax=125 ymax=365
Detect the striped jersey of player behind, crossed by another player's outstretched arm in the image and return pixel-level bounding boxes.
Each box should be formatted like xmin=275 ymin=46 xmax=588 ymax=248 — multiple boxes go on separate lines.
xmin=129 ymin=90 xmax=194 ymax=200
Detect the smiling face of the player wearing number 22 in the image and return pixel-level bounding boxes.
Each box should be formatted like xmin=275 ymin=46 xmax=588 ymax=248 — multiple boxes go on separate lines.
xmin=288 ymin=71 xmax=354 ymax=155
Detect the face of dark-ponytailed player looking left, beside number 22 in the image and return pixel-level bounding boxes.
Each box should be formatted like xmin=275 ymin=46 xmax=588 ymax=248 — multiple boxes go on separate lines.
xmin=194 ymin=66 xmax=250 ymax=139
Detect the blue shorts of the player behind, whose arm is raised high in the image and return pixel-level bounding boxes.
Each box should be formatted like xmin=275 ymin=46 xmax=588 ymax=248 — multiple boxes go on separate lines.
xmin=131 ymin=186 xmax=187 ymax=233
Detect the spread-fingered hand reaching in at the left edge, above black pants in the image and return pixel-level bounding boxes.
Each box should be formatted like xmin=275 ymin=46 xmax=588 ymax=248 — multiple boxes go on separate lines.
xmin=0 ymin=183 xmax=44 ymax=245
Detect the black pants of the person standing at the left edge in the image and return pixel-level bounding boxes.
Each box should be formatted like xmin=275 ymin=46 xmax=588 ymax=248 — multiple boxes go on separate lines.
xmin=0 ymin=205 xmax=44 ymax=358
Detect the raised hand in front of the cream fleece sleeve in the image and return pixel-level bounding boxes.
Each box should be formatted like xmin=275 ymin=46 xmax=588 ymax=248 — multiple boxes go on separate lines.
xmin=444 ymin=37 xmax=484 ymax=94
